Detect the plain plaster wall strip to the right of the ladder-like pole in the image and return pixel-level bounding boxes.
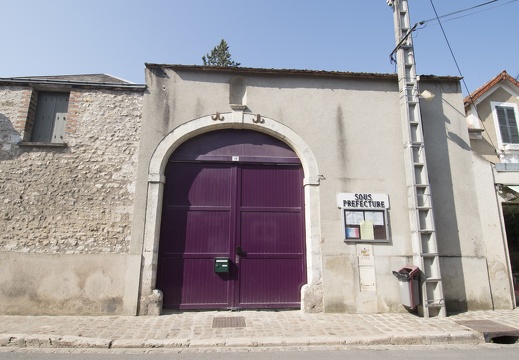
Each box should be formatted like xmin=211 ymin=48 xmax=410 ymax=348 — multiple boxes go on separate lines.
xmin=422 ymin=83 xmax=493 ymax=312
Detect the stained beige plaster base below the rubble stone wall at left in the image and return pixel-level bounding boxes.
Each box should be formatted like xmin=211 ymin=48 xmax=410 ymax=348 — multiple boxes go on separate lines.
xmin=0 ymin=253 xmax=126 ymax=315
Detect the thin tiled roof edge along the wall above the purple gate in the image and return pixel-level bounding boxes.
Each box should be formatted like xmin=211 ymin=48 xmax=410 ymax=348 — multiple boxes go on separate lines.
xmin=145 ymin=63 xmax=461 ymax=81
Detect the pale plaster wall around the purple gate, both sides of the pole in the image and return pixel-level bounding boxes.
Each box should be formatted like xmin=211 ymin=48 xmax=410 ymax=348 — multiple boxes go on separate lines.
xmin=132 ymin=66 xmax=498 ymax=313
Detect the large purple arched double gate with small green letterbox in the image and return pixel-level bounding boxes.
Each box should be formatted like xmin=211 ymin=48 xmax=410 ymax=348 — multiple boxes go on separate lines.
xmin=156 ymin=129 xmax=306 ymax=309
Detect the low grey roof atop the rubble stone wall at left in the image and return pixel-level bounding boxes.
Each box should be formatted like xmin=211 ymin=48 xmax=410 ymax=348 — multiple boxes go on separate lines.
xmin=0 ymin=74 xmax=146 ymax=91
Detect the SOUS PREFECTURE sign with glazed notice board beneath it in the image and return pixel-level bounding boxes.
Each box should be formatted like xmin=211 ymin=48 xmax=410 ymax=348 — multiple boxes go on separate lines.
xmin=337 ymin=193 xmax=389 ymax=242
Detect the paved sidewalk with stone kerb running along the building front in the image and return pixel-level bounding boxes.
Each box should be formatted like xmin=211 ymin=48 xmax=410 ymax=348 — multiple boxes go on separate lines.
xmin=0 ymin=310 xmax=519 ymax=349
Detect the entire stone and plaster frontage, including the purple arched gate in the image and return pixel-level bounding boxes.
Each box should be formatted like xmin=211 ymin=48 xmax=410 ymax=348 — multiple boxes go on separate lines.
xmin=0 ymin=64 xmax=513 ymax=315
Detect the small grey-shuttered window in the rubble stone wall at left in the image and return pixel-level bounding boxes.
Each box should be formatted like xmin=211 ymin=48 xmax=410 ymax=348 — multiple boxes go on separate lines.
xmin=31 ymin=91 xmax=69 ymax=143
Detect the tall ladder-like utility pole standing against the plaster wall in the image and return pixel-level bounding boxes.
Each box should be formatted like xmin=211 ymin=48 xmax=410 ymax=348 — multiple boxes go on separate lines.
xmin=387 ymin=0 xmax=446 ymax=317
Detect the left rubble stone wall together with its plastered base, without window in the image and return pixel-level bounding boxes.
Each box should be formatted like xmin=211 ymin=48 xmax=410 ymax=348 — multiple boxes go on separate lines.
xmin=0 ymin=86 xmax=142 ymax=315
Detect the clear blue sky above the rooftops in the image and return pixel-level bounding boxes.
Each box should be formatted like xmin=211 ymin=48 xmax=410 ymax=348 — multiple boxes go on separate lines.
xmin=0 ymin=0 xmax=519 ymax=93
